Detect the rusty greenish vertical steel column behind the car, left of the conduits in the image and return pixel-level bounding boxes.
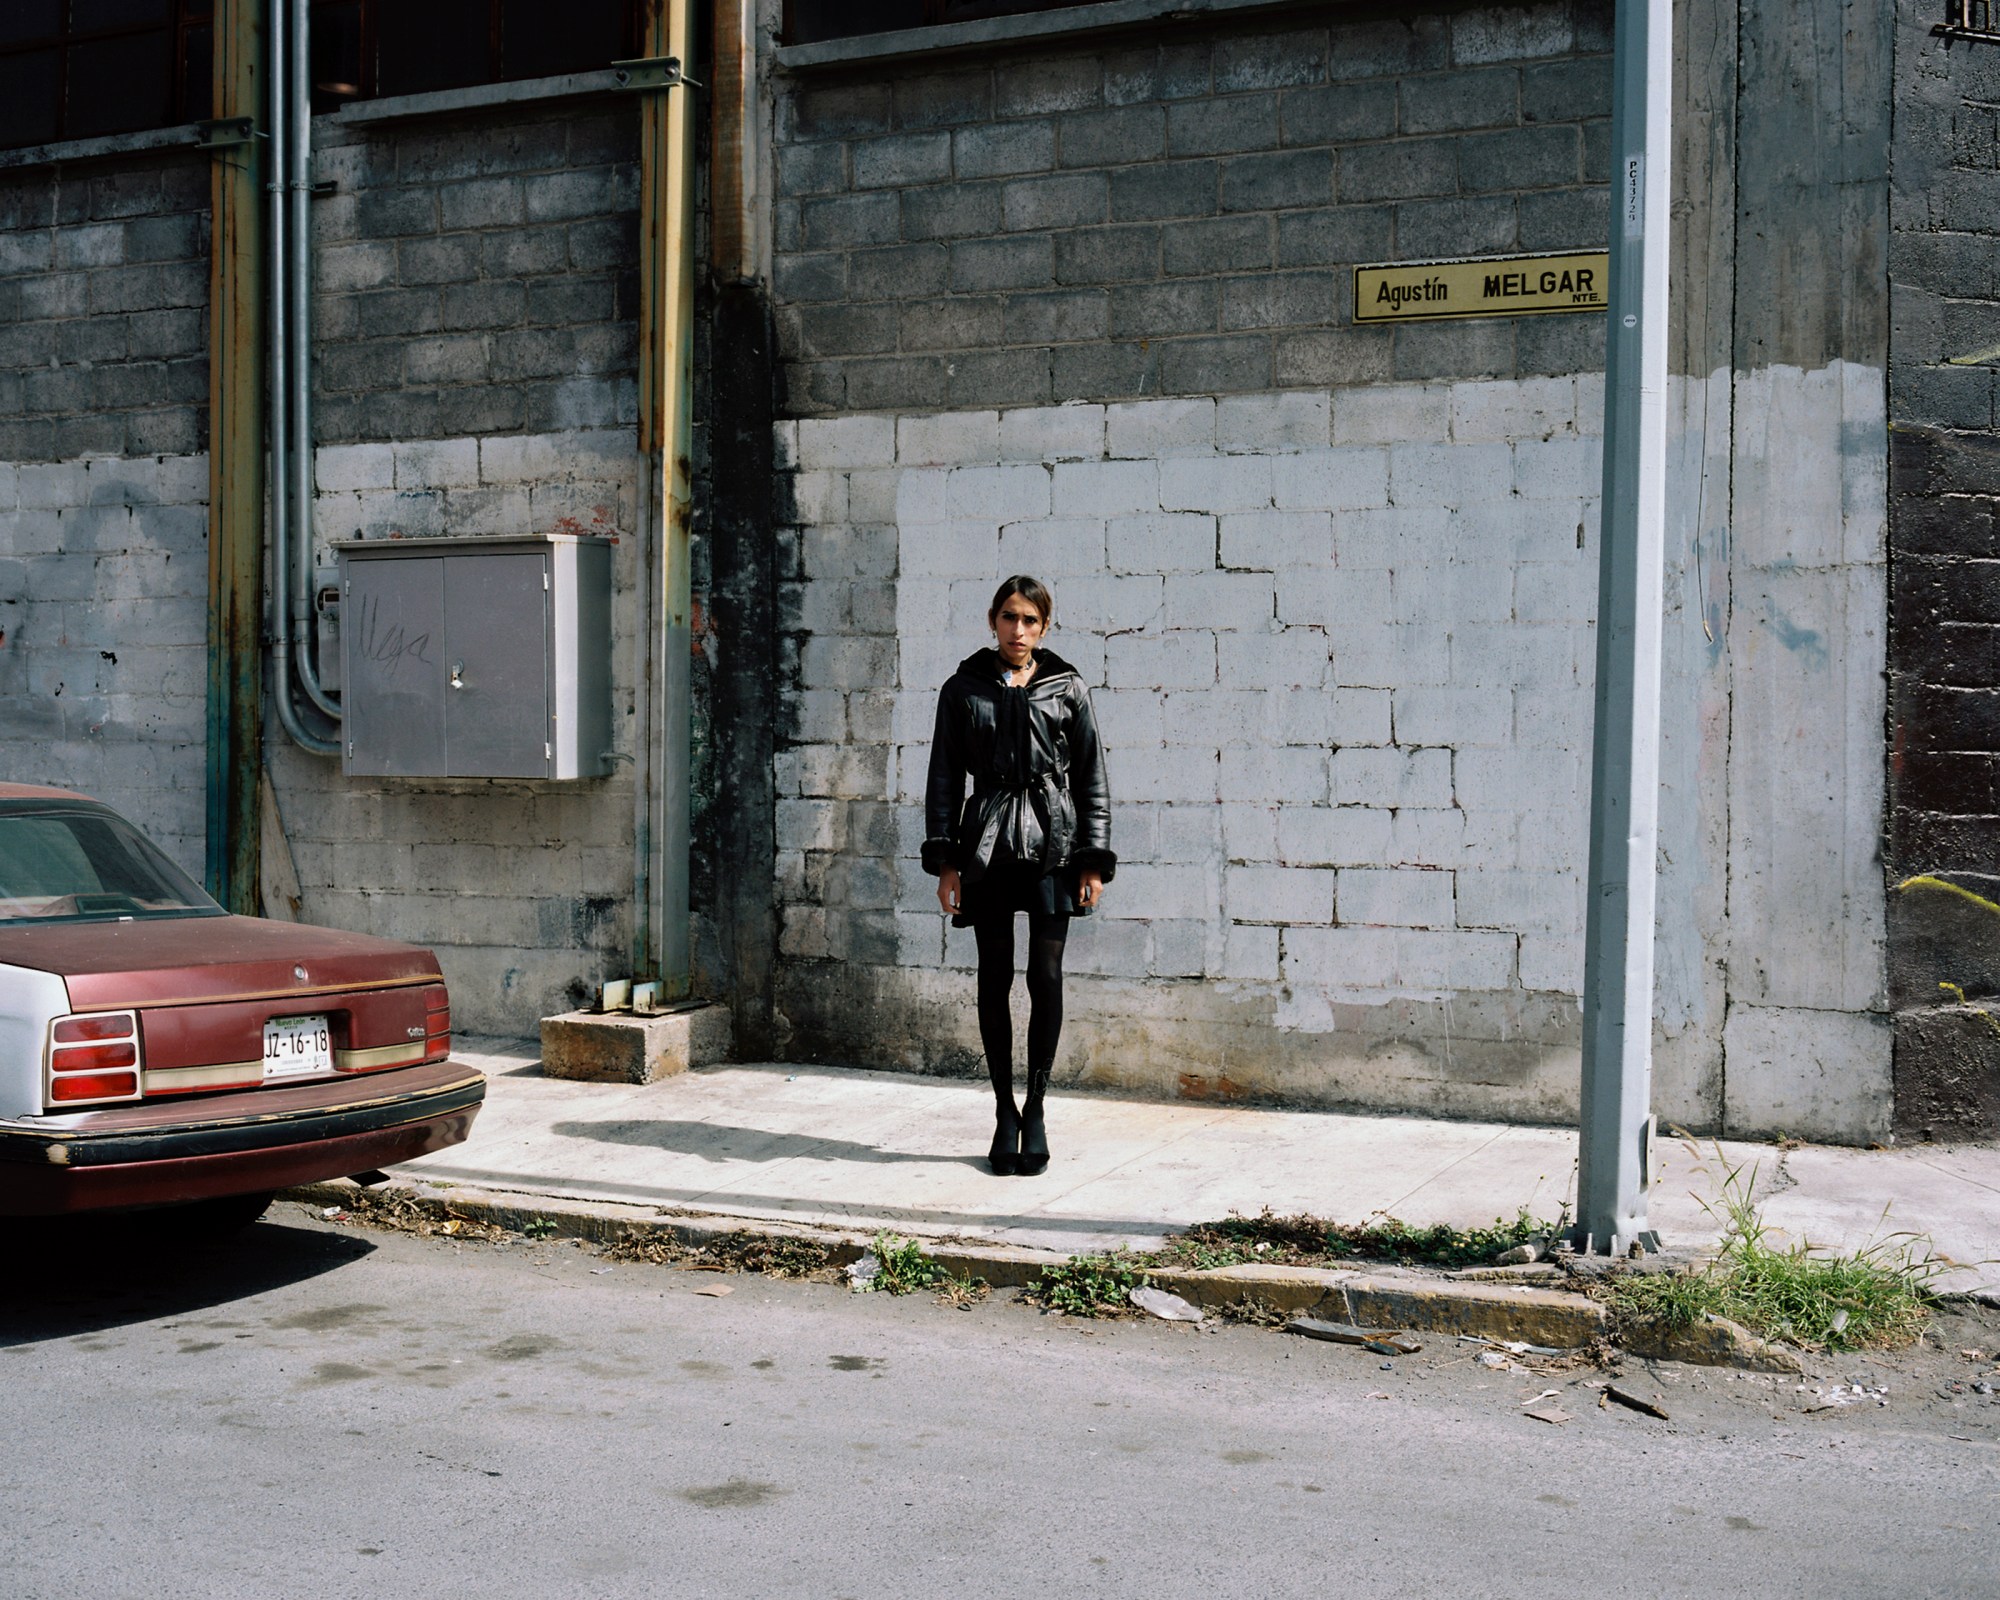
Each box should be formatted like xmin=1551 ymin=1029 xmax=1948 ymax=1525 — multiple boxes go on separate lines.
xmin=206 ymin=0 xmax=266 ymax=914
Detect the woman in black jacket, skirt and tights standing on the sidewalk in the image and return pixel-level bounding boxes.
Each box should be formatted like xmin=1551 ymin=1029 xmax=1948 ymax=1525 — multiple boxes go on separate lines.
xmin=924 ymin=576 xmax=1118 ymax=1174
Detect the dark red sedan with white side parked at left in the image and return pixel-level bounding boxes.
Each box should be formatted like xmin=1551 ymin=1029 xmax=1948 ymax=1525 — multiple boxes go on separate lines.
xmin=0 ymin=784 xmax=486 ymax=1216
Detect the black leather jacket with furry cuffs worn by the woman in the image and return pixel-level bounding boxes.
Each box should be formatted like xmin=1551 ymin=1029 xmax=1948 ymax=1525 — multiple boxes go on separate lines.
xmin=924 ymin=650 xmax=1118 ymax=884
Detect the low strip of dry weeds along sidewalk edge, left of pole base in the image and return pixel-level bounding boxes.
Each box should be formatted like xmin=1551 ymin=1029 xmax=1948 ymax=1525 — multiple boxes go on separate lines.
xmin=1154 ymin=1206 xmax=1568 ymax=1270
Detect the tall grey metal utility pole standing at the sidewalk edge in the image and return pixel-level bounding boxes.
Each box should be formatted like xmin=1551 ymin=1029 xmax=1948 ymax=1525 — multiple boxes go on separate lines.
xmin=1574 ymin=0 xmax=1674 ymax=1254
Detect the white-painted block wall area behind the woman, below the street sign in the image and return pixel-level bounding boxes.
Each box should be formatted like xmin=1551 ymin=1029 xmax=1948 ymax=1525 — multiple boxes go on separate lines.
xmin=780 ymin=378 xmax=1602 ymax=1002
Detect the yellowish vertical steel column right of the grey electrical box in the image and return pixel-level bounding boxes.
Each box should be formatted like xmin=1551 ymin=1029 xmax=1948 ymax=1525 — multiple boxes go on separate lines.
xmin=634 ymin=0 xmax=694 ymax=1000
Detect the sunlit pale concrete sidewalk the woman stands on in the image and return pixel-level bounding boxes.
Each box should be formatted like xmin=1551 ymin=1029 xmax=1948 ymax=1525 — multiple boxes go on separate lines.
xmin=410 ymin=1040 xmax=2000 ymax=1290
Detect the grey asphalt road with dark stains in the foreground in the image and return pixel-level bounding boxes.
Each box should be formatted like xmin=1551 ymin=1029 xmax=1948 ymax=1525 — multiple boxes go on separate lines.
xmin=0 ymin=1206 xmax=2000 ymax=1600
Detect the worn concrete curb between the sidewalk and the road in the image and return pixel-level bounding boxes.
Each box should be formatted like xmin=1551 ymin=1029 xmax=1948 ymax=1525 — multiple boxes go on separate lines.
xmin=278 ymin=1178 xmax=1800 ymax=1372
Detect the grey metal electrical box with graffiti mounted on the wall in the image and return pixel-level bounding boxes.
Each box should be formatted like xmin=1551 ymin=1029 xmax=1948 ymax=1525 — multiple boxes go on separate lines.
xmin=334 ymin=534 xmax=612 ymax=778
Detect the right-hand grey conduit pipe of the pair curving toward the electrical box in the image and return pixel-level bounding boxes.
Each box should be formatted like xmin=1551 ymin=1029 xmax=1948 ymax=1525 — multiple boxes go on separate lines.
xmin=288 ymin=0 xmax=340 ymax=722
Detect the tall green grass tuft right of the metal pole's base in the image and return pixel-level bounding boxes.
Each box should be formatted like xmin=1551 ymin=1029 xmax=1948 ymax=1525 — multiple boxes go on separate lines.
xmin=1602 ymin=1152 xmax=1942 ymax=1350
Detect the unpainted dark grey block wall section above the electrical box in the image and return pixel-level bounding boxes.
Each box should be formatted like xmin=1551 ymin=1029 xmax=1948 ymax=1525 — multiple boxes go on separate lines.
xmin=312 ymin=102 xmax=638 ymax=444
